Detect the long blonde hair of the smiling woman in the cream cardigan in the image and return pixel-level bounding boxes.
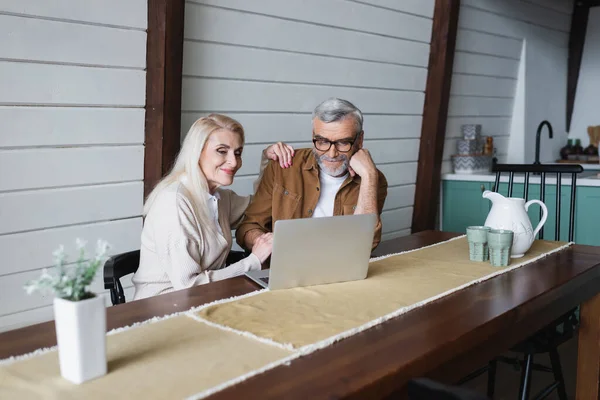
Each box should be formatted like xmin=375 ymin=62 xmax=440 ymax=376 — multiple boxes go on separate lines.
xmin=143 ymin=114 xmax=244 ymax=231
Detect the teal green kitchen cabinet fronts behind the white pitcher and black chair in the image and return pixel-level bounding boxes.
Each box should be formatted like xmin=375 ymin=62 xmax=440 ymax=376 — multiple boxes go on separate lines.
xmin=442 ymin=180 xmax=600 ymax=246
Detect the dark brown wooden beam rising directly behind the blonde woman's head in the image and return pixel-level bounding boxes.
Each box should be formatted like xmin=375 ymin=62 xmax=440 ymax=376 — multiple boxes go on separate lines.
xmin=144 ymin=0 xmax=185 ymax=197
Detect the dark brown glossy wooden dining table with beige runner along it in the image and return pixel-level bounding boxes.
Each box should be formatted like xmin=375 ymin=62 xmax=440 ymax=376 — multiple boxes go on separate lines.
xmin=0 ymin=231 xmax=600 ymax=400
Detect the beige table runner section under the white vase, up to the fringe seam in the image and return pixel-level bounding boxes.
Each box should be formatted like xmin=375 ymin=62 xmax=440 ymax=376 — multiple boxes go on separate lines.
xmin=0 ymin=315 xmax=290 ymax=399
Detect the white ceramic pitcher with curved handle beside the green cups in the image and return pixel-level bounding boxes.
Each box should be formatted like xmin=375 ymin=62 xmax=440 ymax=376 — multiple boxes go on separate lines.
xmin=483 ymin=190 xmax=548 ymax=258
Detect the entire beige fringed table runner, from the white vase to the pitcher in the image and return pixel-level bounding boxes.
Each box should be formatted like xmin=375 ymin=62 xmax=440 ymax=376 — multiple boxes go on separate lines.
xmin=0 ymin=237 xmax=568 ymax=399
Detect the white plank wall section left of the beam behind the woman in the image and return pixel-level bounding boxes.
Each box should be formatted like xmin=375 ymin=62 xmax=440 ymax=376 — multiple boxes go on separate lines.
xmin=0 ymin=0 xmax=148 ymax=331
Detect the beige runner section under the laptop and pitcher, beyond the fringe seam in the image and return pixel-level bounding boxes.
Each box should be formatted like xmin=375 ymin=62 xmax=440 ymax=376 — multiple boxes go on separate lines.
xmin=197 ymin=238 xmax=565 ymax=349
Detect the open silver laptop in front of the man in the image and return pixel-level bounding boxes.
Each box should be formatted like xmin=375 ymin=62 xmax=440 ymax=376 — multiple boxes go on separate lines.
xmin=246 ymin=214 xmax=377 ymax=290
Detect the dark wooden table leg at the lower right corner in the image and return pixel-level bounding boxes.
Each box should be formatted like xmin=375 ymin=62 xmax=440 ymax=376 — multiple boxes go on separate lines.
xmin=576 ymin=293 xmax=600 ymax=400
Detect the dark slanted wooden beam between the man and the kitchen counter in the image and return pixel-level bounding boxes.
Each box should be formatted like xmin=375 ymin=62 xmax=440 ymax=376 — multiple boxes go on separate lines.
xmin=412 ymin=0 xmax=460 ymax=233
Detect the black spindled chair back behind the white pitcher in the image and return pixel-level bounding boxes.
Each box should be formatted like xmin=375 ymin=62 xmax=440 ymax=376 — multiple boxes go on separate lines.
xmin=492 ymin=164 xmax=583 ymax=242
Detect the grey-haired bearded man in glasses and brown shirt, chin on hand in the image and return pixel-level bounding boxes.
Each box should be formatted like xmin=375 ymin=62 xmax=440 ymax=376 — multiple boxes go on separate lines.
xmin=236 ymin=98 xmax=387 ymax=249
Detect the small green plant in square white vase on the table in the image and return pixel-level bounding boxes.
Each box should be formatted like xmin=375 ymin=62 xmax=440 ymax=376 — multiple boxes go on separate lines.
xmin=25 ymin=239 xmax=108 ymax=384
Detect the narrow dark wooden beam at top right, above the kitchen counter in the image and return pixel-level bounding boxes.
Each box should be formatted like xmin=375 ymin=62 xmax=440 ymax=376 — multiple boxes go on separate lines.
xmin=567 ymin=1 xmax=590 ymax=132
